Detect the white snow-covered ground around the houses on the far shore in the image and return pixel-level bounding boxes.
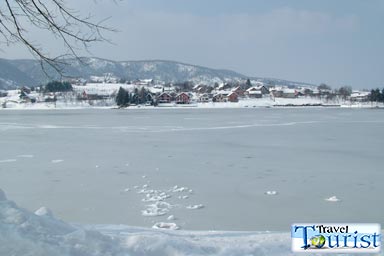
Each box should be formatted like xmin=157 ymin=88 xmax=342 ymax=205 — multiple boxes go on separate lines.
xmin=0 ymin=82 xmax=384 ymax=109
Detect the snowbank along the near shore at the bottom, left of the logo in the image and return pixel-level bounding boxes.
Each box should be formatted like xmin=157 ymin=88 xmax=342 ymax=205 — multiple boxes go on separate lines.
xmin=0 ymin=189 xmax=380 ymax=256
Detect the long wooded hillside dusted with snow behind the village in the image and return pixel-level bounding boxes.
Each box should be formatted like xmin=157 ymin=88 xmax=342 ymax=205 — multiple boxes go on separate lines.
xmin=0 ymin=58 xmax=312 ymax=89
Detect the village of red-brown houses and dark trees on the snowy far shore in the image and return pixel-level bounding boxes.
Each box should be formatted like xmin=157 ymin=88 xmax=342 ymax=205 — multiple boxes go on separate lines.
xmin=0 ymin=74 xmax=378 ymax=108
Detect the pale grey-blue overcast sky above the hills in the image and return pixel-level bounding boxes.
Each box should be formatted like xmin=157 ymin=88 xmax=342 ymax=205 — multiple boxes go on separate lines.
xmin=0 ymin=0 xmax=384 ymax=89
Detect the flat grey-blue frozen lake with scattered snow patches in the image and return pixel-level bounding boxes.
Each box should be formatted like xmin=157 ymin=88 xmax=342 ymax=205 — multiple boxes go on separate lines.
xmin=0 ymin=108 xmax=384 ymax=232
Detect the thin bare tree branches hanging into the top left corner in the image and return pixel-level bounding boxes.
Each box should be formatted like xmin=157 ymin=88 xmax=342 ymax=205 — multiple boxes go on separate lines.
xmin=0 ymin=0 xmax=113 ymax=73
